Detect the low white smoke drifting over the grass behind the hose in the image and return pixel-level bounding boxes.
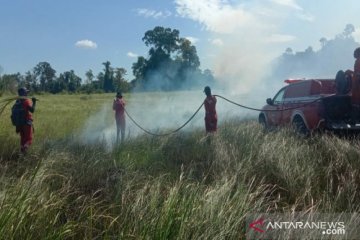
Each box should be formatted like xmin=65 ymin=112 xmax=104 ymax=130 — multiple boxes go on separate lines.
xmin=80 ymin=88 xmax=264 ymax=146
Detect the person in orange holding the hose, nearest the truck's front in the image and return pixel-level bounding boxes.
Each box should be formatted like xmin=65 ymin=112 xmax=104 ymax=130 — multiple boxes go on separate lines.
xmin=204 ymin=86 xmax=217 ymax=133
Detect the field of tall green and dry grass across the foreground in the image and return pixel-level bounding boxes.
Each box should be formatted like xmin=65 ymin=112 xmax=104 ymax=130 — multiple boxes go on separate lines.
xmin=0 ymin=94 xmax=360 ymax=239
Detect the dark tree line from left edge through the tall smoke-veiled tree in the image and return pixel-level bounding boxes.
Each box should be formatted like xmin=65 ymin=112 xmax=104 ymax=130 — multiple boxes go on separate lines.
xmin=0 ymin=26 xmax=214 ymax=94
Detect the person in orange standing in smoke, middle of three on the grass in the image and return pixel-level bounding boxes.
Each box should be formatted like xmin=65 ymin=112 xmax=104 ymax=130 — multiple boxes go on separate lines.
xmin=113 ymin=92 xmax=125 ymax=142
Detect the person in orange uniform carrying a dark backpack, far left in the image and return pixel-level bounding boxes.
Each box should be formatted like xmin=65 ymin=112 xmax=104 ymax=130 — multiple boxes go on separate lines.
xmin=16 ymin=87 xmax=36 ymax=153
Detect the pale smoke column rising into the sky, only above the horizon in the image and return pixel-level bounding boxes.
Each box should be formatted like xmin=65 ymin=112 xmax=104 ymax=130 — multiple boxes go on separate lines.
xmin=175 ymin=0 xmax=310 ymax=95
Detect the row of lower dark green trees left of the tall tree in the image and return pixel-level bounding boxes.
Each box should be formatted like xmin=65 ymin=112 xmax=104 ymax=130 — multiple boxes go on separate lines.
xmin=0 ymin=61 xmax=130 ymax=94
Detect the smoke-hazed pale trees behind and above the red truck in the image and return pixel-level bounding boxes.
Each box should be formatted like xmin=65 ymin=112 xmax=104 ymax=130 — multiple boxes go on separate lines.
xmin=271 ymin=24 xmax=360 ymax=81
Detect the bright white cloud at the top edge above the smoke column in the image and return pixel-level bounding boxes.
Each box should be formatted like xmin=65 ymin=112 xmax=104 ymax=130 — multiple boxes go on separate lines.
xmin=175 ymin=0 xmax=314 ymax=34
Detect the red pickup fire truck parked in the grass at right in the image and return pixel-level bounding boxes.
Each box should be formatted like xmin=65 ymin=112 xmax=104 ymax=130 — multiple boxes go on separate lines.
xmin=259 ymin=79 xmax=360 ymax=134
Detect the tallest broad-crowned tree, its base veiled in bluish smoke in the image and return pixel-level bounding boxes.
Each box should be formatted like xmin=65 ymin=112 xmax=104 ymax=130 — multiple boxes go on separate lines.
xmin=132 ymin=26 xmax=202 ymax=90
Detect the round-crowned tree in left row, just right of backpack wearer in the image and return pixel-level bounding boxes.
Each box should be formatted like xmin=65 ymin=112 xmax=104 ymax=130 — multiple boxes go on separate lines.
xmin=34 ymin=62 xmax=56 ymax=91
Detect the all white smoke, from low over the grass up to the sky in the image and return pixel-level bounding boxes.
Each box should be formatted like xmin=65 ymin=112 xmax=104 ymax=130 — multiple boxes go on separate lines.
xmin=80 ymin=0 xmax=314 ymax=145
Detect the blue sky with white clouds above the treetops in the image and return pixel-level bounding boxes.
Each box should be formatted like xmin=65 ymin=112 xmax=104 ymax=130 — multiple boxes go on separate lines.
xmin=0 ymin=0 xmax=360 ymax=80
